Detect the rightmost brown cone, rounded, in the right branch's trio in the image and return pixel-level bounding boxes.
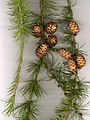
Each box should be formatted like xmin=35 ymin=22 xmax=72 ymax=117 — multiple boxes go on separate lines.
xmin=76 ymin=54 xmax=86 ymax=68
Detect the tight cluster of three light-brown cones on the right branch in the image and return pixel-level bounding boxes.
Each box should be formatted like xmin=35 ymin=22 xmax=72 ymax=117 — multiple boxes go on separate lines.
xmin=59 ymin=48 xmax=86 ymax=74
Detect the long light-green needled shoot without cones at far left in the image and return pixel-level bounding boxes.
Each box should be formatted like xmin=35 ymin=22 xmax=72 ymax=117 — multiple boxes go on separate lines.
xmin=4 ymin=0 xmax=30 ymax=115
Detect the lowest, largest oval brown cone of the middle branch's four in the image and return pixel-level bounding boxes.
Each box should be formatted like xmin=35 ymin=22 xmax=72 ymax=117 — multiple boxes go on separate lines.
xmin=35 ymin=43 xmax=49 ymax=58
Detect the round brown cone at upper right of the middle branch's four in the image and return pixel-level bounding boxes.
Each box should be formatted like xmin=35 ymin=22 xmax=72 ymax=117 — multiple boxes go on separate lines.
xmin=45 ymin=21 xmax=57 ymax=34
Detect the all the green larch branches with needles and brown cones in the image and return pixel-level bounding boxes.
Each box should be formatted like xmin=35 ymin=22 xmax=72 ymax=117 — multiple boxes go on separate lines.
xmin=4 ymin=0 xmax=88 ymax=120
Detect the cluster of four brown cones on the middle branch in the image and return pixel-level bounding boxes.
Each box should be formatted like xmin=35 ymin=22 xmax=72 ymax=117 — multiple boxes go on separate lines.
xmin=33 ymin=21 xmax=58 ymax=58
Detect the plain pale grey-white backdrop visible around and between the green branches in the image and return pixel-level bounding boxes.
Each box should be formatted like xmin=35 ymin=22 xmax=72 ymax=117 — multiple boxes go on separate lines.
xmin=0 ymin=0 xmax=90 ymax=120
